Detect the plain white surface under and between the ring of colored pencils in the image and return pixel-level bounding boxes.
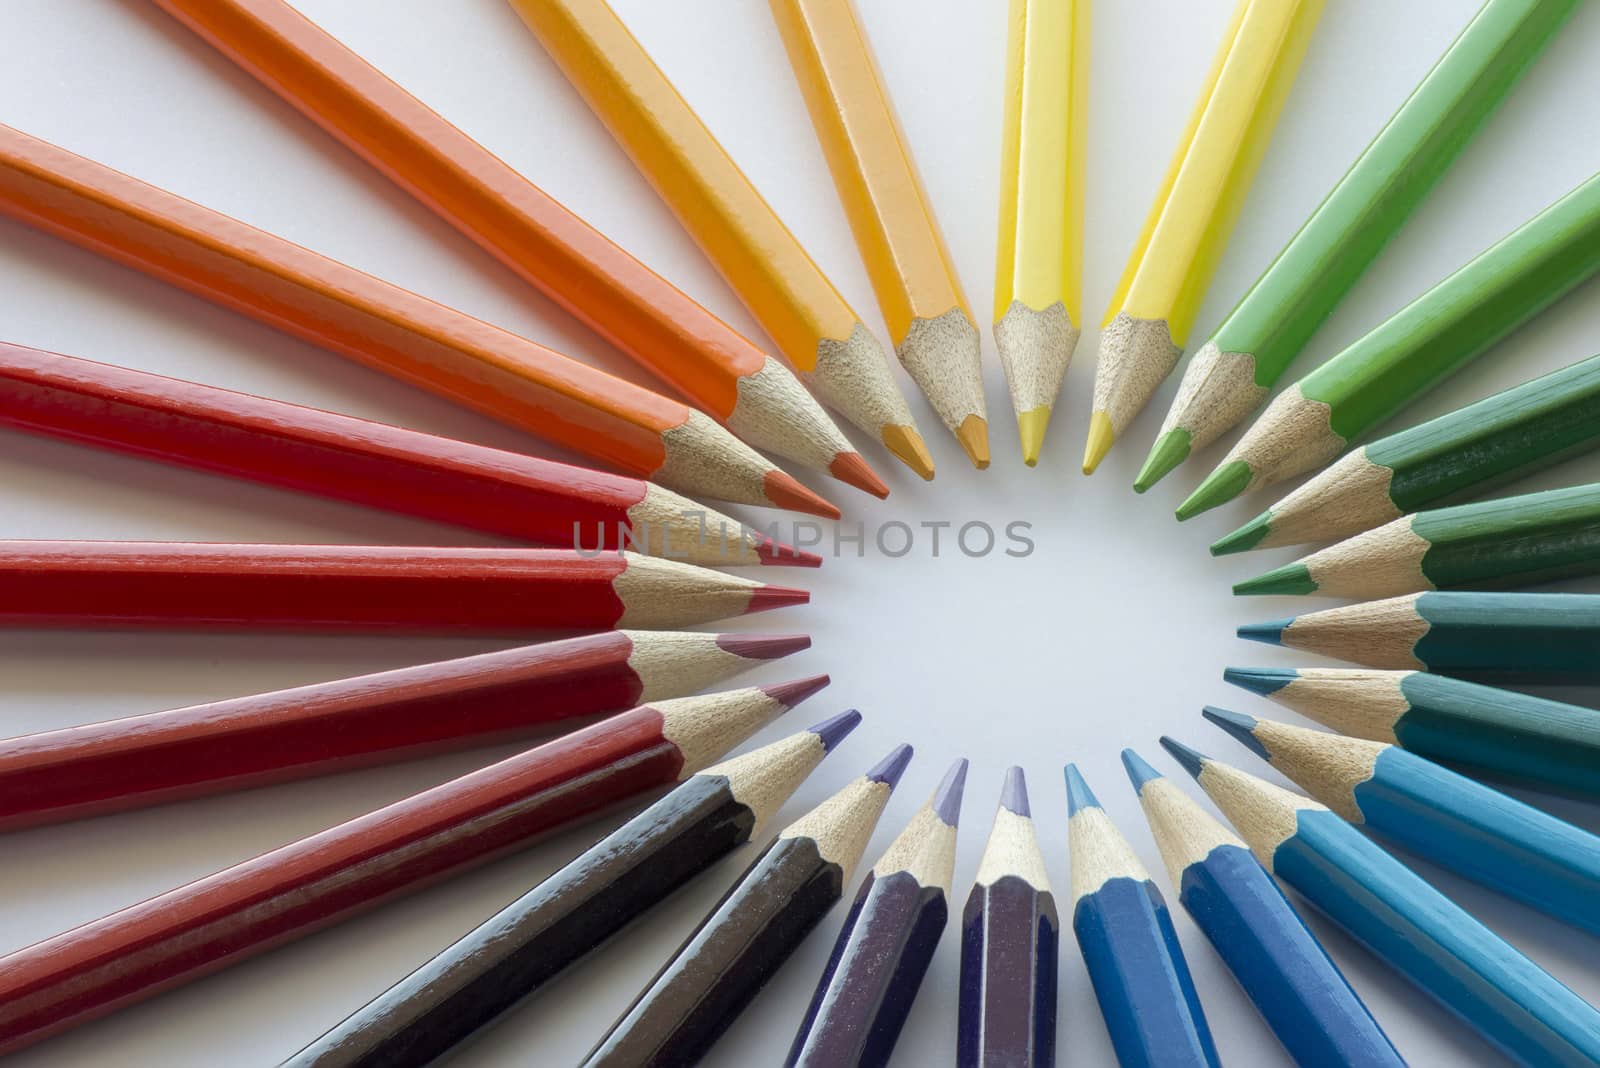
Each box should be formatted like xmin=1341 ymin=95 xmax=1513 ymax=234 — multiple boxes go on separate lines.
xmin=0 ymin=0 xmax=1600 ymax=1066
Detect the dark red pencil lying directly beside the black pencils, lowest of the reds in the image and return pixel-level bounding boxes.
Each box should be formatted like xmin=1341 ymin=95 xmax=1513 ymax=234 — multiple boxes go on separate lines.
xmin=0 ymin=676 xmax=827 ymax=1054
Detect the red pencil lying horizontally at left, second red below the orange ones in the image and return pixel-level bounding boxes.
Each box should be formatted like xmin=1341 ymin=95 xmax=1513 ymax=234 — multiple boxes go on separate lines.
xmin=0 ymin=540 xmax=810 ymax=633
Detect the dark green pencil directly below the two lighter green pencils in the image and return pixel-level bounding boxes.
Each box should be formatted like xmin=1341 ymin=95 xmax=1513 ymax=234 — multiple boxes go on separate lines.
xmin=1211 ymin=357 xmax=1600 ymax=556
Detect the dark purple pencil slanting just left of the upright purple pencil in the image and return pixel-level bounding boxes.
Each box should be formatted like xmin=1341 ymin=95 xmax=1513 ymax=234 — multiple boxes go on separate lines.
xmin=784 ymin=759 xmax=966 ymax=1068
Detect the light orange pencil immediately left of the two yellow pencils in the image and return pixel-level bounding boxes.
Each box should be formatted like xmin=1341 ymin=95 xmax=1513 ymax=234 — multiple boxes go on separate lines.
xmin=770 ymin=0 xmax=989 ymax=470
